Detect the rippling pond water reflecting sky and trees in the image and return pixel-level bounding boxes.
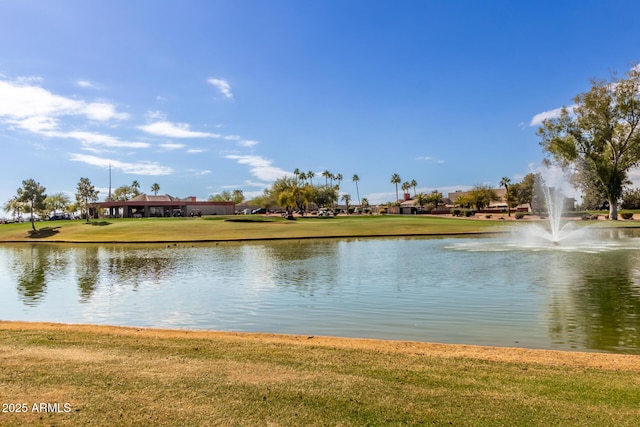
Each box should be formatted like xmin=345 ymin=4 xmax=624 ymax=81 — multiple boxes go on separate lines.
xmin=0 ymin=230 xmax=640 ymax=354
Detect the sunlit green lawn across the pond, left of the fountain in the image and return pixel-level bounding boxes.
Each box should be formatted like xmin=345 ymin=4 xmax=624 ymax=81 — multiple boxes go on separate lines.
xmin=0 ymin=215 xmax=516 ymax=242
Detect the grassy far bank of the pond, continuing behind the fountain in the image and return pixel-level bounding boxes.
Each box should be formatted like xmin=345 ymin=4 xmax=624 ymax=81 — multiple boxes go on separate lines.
xmin=0 ymin=215 xmax=640 ymax=245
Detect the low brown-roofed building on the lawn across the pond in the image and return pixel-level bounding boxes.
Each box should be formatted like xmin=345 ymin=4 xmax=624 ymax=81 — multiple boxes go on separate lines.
xmin=97 ymin=194 xmax=235 ymax=218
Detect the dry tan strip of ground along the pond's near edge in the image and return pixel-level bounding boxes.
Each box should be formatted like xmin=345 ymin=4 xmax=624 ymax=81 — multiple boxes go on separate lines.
xmin=5 ymin=320 xmax=640 ymax=372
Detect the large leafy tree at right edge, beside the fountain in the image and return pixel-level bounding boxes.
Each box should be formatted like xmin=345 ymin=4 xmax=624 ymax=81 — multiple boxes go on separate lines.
xmin=538 ymin=66 xmax=640 ymax=220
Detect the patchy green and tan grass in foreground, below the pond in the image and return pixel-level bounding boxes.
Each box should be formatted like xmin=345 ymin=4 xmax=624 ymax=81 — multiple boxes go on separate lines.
xmin=0 ymin=322 xmax=640 ymax=426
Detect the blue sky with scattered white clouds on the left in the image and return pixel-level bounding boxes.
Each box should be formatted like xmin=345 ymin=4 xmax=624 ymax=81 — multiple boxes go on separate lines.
xmin=0 ymin=0 xmax=640 ymax=211
